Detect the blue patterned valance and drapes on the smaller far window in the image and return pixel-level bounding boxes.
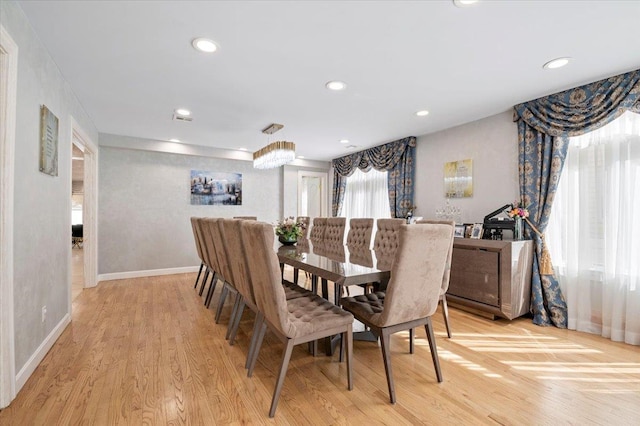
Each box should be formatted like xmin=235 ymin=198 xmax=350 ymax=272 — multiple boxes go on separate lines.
xmin=331 ymin=136 xmax=416 ymax=217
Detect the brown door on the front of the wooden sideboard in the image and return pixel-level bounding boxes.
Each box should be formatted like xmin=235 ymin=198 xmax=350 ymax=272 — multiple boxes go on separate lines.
xmin=447 ymin=247 xmax=500 ymax=307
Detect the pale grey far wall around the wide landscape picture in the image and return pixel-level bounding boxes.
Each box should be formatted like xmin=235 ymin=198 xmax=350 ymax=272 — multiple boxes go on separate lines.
xmin=98 ymin=134 xmax=283 ymax=278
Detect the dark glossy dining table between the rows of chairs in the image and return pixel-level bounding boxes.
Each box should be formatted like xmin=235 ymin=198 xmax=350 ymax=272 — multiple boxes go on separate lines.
xmin=276 ymin=239 xmax=393 ymax=355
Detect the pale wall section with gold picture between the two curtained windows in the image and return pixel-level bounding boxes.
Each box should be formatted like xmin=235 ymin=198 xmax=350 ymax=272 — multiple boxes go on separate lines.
xmin=414 ymin=111 xmax=518 ymax=223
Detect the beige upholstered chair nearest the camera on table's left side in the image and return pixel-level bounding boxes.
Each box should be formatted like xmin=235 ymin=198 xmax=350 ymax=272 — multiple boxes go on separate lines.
xmin=240 ymin=221 xmax=353 ymax=417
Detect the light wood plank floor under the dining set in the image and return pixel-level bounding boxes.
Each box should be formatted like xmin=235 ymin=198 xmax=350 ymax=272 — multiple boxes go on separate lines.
xmin=0 ymin=274 xmax=640 ymax=425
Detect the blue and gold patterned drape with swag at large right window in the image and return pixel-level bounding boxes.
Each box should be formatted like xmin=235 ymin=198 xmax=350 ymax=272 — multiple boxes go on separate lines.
xmin=514 ymin=70 xmax=640 ymax=328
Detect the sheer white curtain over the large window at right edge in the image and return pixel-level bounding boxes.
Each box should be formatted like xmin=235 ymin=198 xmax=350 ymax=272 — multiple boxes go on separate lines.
xmin=546 ymin=112 xmax=640 ymax=345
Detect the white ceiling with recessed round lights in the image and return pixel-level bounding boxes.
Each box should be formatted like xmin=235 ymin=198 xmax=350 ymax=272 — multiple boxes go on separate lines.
xmin=18 ymin=0 xmax=640 ymax=160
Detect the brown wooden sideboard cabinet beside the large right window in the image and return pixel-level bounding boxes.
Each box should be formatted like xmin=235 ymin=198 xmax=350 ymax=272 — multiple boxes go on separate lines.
xmin=447 ymin=238 xmax=533 ymax=319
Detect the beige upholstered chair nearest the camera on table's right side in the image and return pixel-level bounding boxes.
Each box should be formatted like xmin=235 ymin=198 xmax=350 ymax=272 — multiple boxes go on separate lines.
xmin=341 ymin=224 xmax=453 ymax=404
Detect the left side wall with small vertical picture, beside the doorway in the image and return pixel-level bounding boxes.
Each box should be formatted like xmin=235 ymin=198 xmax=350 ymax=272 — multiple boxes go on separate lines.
xmin=0 ymin=1 xmax=98 ymax=378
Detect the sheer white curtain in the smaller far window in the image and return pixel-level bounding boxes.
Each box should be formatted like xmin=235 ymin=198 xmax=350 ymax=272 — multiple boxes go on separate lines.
xmin=342 ymin=168 xmax=391 ymax=224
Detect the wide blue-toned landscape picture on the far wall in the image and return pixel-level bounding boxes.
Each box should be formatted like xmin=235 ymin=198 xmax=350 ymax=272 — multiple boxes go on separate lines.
xmin=191 ymin=170 xmax=242 ymax=206
